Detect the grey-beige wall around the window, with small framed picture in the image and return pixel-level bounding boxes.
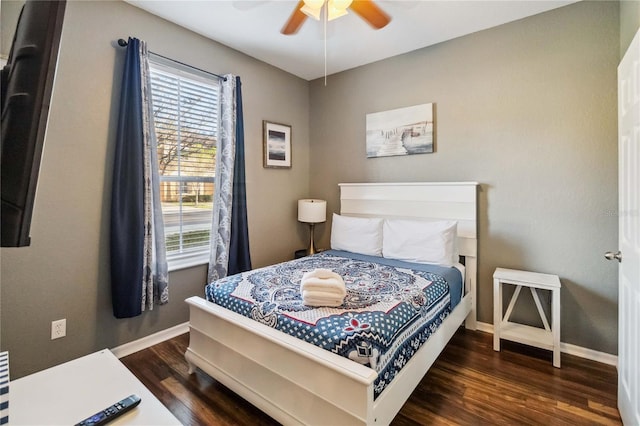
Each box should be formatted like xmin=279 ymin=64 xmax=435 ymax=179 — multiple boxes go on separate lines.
xmin=0 ymin=1 xmax=309 ymax=378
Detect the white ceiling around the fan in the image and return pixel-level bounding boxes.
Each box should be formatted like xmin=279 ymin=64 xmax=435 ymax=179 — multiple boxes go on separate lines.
xmin=126 ymin=0 xmax=576 ymax=80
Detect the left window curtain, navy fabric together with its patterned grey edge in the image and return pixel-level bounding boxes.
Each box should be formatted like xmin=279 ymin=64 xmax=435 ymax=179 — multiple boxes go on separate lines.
xmin=111 ymin=37 xmax=168 ymax=318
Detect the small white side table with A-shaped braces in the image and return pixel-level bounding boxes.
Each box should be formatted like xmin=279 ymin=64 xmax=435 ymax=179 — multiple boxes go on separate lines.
xmin=493 ymin=268 xmax=560 ymax=368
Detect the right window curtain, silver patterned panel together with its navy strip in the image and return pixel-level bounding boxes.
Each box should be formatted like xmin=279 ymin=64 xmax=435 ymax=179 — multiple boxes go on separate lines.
xmin=208 ymin=74 xmax=251 ymax=282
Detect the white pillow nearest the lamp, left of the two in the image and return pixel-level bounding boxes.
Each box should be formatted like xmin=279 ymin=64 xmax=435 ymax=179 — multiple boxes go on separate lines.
xmin=331 ymin=213 xmax=383 ymax=256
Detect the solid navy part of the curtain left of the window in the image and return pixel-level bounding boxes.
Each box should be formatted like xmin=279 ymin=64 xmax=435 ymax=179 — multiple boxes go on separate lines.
xmin=111 ymin=38 xmax=144 ymax=318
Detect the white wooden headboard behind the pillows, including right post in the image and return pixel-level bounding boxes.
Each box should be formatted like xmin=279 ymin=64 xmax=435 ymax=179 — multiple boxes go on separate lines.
xmin=339 ymin=182 xmax=478 ymax=329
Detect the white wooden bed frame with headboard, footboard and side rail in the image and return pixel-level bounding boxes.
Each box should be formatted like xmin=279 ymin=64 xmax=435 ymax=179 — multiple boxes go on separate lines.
xmin=185 ymin=182 xmax=477 ymax=425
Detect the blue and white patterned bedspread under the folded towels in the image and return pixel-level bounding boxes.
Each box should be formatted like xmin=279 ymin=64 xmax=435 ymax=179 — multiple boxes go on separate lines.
xmin=205 ymin=250 xmax=462 ymax=398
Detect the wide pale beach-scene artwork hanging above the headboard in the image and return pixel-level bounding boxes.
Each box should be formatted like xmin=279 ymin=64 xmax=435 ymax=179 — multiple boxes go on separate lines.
xmin=366 ymin=103 xmax=435 ymax=158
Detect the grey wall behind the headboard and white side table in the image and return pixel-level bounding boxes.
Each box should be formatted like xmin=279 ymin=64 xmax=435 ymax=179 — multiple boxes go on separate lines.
xmin=310 ymin=2 xmax=620 ymax=354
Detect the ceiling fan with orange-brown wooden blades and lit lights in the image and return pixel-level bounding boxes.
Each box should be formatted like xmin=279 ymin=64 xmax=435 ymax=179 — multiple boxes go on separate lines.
xmin=280 ymin=0 xmax=391 ymax=35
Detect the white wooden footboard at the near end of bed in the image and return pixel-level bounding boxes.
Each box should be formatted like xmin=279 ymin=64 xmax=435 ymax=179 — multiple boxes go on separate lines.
xmin=185 ymin=297 xmax=377 ymax=425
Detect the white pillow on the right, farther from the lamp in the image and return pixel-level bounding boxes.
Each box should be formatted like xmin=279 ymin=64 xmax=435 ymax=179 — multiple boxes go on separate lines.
xmin=382 ymin=219 xmax=458 ymax=266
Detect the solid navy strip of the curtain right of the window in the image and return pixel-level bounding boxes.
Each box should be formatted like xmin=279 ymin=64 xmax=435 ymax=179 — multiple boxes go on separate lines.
xmin=228 ymin=77 xmax=251 ymax=275
